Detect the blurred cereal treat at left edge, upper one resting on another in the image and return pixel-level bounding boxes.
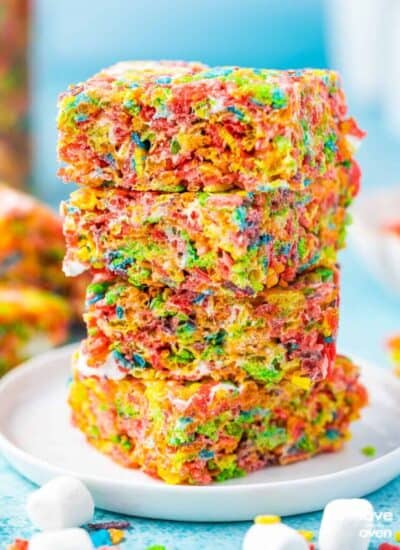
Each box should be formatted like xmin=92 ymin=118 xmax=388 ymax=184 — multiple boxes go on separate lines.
xmin=0 ymin=184 xmax=85 ymax=311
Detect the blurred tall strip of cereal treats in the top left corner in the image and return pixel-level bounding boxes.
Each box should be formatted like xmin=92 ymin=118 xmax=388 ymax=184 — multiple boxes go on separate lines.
xmin=0 ymin=0 xmax=31 ymax=188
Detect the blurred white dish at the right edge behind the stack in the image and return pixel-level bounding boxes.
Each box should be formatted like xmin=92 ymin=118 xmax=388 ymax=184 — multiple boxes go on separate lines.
xmin=350 ymin=186 xmax=400 ymax=294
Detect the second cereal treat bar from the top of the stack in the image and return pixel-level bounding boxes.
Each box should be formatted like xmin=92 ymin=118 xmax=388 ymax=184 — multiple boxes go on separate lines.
xmin=62 ymin=176 xmax=350 ymax=294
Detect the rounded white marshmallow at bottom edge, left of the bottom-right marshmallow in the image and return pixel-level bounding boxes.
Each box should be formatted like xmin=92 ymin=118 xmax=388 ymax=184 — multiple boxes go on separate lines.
xmin=241 ymin=523 xmax=308 ymax=550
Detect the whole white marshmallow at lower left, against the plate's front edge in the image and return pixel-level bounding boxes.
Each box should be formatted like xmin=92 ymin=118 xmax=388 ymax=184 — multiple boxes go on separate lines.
xmin=26 ymin=476 xmax=94 ymax=531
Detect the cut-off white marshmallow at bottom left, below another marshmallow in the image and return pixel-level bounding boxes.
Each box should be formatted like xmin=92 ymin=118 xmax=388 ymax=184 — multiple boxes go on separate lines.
xmin=28 ymin=529 xmax=94 ymax=550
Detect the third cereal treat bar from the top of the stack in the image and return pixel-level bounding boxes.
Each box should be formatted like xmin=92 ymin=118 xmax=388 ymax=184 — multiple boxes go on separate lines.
xmin=79 ymin=268 xmax=339 ymax=387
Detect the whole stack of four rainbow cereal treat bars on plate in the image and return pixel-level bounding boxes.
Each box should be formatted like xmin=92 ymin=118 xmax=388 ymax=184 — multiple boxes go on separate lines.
xmin=58 ymin=62 xmax=367 ymax=484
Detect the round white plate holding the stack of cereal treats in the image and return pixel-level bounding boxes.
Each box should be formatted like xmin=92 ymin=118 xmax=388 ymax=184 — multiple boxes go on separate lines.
xmin=0 ymin=346 xmax=400 ymax=521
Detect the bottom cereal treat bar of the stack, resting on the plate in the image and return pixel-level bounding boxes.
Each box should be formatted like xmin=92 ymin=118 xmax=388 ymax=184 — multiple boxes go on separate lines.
xmin=69 ymin=357 xmax=367 ymax=484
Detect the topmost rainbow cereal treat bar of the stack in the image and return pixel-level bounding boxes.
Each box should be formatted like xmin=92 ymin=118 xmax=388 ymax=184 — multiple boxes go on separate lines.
xmin=58 ymin=62 xmax=364 ymax=192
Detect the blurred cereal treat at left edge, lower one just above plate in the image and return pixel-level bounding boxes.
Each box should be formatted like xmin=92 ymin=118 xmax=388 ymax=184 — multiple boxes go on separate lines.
xmin=0 ymin=285 xmax=71 ymax=375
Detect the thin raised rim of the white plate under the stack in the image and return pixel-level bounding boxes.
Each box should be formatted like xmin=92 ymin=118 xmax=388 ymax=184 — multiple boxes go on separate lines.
xmin=0 ymin=342 xmax=400 ymax=494
